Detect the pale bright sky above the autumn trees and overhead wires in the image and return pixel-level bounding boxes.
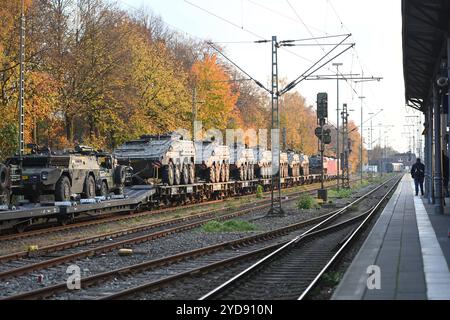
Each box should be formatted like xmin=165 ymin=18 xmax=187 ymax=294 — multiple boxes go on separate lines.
xmin=115 ymin=0 xmax=423 ymax=152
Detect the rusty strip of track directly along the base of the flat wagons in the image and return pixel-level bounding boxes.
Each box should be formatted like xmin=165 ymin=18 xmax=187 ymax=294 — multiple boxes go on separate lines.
xmin=0 ymin=180 xmax=342 ymax=244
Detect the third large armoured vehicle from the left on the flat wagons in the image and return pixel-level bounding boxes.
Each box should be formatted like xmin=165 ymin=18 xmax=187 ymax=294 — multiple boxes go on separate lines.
xmin=230 ymin=144 xmax=256 ymax=181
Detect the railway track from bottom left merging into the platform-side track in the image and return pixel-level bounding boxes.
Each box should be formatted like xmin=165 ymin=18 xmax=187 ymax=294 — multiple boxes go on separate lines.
xmin=0 ymin=175 xmax=398 ymax=299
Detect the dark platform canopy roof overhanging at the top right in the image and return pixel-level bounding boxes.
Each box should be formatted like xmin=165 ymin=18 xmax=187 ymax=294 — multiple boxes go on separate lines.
xmin=402 ymin=0 xmax=450 ymax=111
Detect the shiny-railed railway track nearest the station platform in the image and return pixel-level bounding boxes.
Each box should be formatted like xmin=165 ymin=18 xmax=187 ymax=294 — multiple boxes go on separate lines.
xmin=201 ymin=175 xmax=400 ymax=300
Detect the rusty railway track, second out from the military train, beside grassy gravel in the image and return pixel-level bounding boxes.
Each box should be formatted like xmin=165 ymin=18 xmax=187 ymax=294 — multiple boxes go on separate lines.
xmin=0 ymin=180 xmax=348 ymax=280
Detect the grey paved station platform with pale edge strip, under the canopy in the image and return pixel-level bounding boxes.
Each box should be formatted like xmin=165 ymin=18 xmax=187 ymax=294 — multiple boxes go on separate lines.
xmin=332 ymin=175 xmax=450 ymax=300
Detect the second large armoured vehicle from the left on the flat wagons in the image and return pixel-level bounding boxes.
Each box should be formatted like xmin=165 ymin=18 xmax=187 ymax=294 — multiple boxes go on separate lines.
xmin=195 ymin=141 xmax=230 ymax=183
